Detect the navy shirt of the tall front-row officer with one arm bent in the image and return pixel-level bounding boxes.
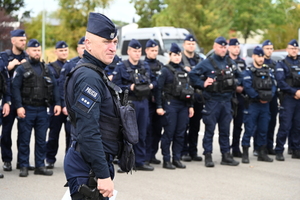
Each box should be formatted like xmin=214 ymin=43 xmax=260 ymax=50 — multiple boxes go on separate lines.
xmin=189 ymin=54 xmax=242 ymax=101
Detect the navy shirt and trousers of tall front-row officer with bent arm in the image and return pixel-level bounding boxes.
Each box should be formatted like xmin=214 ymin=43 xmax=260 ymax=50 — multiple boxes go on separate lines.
xmin=189 ymin=54 xmax=241 ymax=155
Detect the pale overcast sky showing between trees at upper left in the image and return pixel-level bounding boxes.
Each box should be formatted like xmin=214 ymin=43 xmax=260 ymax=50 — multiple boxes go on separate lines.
xmin=24 ymin=0 xmax=139 ymax=23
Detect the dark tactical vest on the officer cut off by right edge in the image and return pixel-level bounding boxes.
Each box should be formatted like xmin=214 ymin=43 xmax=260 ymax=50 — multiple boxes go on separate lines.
xmin=282 ymin=58 xmax=300 ymax=87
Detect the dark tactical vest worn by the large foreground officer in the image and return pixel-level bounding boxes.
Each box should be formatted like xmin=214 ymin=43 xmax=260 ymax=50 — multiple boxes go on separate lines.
xmin=65 ymin=63 xmax=122 ymax=141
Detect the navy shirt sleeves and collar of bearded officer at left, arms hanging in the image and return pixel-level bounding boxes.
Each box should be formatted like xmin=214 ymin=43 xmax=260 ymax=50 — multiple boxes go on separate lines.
xmin=12 ymin=60 xmax=60 ymax=108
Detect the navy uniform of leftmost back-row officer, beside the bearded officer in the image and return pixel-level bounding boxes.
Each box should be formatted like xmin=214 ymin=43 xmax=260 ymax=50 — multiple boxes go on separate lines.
xmin=0 ymin=51 xmax=28 ymax=162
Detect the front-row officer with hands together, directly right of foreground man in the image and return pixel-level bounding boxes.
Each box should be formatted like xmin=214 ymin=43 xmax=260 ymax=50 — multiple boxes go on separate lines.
xmin=112 ymin=39 xmax=156 ymax=171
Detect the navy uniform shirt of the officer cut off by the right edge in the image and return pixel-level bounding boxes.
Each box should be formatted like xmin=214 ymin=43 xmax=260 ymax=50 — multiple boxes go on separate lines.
xmin=275 ymin=56 xmax=300 ymax=96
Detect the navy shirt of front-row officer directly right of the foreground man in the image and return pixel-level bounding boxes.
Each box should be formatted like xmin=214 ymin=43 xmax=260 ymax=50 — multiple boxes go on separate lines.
xmin=112 ymin=60 xmax=156 ymax=95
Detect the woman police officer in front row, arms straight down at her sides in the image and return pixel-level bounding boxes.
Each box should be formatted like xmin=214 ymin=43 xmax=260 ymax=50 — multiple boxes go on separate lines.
xmin=156 ymin=43 xmax=194 ymax=169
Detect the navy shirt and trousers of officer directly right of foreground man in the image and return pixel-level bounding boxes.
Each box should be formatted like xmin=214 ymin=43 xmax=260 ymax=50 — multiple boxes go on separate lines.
xmin=112 ymin=60 xmax=156 ymax=167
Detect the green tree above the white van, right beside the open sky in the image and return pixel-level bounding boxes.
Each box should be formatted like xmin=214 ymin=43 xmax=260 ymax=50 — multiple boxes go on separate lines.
xmin=130 ymin=0 xmax=164 ymax=28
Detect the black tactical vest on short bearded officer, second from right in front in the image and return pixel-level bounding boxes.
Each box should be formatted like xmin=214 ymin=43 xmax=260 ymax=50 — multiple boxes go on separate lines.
xmin=251 ymin=67 xmax=273 ymax=101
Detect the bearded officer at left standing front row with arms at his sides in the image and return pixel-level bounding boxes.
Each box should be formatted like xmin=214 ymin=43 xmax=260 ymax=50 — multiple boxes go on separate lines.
xmin=12 ymin=39 xmax=61 ymax=177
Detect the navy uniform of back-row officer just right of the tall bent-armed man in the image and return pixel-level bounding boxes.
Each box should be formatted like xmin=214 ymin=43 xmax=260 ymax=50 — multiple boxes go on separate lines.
xmin=231 ymin=56 xmax=247 ymax=156
